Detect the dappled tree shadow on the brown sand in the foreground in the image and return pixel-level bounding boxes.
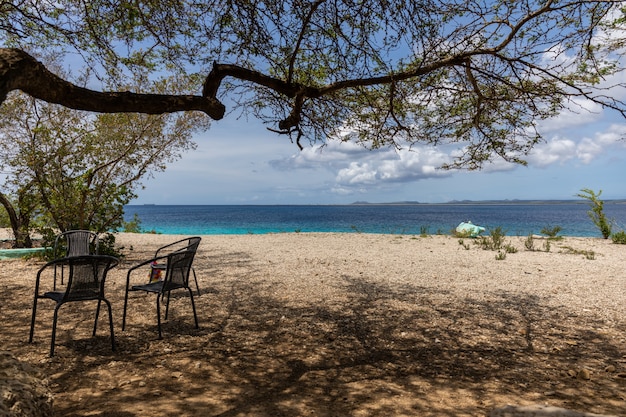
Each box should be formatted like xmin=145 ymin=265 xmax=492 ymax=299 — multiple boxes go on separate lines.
xmin=0 ymin=253 xmax=626 ymax=417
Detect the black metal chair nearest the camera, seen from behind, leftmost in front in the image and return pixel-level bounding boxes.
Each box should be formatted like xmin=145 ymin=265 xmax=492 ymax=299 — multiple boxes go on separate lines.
xmin=28 ymin=255 xmax=119 ymax=356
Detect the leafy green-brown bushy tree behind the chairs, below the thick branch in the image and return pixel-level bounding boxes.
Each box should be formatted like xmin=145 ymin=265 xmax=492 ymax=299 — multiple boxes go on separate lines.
xmin=0 ymin=59 xmax=206 ymax=242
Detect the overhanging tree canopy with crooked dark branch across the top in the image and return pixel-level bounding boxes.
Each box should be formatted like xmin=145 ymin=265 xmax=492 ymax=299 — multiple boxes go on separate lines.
xmin=0 ymin=0 xmax=626 ymax=168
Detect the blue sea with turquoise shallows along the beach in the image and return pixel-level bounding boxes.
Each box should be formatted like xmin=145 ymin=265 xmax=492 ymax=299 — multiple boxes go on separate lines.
xmin=125 ymin=201 xmax=626 ymax=237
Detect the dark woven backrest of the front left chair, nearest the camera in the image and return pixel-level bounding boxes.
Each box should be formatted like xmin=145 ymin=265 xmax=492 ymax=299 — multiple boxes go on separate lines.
xmin=57 ymin=255 xmax=119 ymax=302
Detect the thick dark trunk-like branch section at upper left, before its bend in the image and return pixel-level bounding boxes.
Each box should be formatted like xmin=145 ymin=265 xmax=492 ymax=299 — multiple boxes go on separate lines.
xmin=0 ymin=48 xmax=225 ymax=120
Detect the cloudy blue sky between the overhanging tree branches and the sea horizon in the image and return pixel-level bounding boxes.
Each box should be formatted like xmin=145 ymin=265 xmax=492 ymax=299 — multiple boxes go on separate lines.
xmin=133 ymin=100 xmax=626 ymax=204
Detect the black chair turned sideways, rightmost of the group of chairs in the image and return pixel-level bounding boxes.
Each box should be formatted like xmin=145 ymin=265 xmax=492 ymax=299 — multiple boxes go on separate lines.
xmin=122 ymin=250 xmax=199 ymax=339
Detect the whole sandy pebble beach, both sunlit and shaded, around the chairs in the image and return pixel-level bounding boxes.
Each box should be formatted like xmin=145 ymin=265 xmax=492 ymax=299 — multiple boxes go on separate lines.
xmin=0 ymin=233 xmax=626 ymax=417
